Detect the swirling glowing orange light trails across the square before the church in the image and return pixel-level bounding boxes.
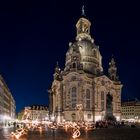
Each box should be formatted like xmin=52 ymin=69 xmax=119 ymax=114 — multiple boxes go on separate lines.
xmin=11 ymin=104 xmax=95 ymax=139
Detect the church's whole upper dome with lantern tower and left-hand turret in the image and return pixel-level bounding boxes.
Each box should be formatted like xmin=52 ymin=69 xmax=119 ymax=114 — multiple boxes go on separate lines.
xmin=65 ymin=17 xmax=103 ymax=75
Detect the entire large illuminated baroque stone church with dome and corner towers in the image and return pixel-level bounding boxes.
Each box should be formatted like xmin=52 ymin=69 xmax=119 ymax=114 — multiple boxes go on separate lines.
xmin=49 ymin=11 xmax=122 ymax=121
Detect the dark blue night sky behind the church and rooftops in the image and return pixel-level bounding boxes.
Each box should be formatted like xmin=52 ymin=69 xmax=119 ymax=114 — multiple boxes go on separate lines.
xmin=0 ymin=0 xmax=140 ymax=111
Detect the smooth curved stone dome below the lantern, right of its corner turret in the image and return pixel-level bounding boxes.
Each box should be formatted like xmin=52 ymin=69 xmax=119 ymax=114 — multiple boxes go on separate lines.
xmin=77 ymin=40 xmax=102 ymax=75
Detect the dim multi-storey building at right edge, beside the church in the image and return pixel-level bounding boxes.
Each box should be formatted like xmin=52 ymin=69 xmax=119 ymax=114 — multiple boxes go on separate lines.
xmin=121 ymin=100 xmax=140 ymax=121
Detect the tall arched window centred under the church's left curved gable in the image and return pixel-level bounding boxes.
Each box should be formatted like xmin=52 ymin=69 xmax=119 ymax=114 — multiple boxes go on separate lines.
xmin=71 ymin=87 xmax=77 ymax=108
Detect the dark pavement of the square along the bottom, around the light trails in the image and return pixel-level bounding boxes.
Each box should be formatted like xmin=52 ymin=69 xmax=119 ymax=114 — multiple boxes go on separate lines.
xmin=0 ymin=128 xmax=140 ymax=140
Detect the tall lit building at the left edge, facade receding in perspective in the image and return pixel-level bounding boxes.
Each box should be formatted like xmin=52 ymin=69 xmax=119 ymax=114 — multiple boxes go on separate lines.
xmin=0 ymin=75 xmax=16 ymax=125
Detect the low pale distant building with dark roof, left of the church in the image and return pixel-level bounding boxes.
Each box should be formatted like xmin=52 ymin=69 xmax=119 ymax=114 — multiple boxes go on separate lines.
xmin=18 ymin=105 xmax=49 ymax=121
